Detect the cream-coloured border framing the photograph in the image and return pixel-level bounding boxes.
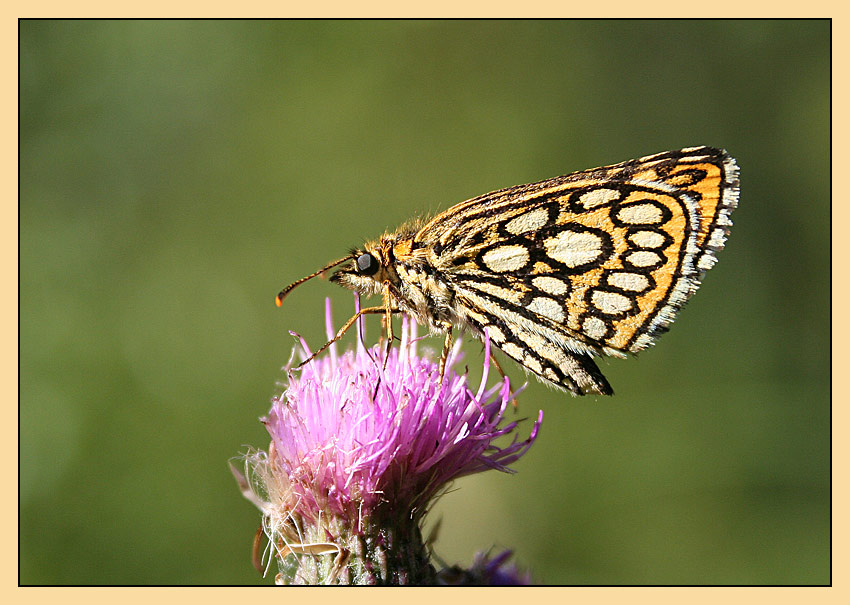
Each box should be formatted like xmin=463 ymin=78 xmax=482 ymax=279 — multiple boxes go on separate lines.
xmin=6 ymin=5 xmax=850 ymax=605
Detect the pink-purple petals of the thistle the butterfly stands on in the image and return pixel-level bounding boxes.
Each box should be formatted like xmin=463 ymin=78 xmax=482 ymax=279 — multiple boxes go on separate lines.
xmin=255 ymin=299 xmax=542 ymax=523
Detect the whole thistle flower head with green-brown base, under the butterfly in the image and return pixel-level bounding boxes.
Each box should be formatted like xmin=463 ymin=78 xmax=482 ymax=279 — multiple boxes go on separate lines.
xmin=234 ymin=301 xmax=542 ymax=585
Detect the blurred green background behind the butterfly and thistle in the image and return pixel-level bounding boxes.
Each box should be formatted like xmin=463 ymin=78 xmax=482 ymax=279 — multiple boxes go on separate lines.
xmin=20 ymin=21 xmax=830 ymax=584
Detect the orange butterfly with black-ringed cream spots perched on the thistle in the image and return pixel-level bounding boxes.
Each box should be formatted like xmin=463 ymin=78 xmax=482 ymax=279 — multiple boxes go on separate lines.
xmin=276 ymin=147 xmax=740 ymax=395
